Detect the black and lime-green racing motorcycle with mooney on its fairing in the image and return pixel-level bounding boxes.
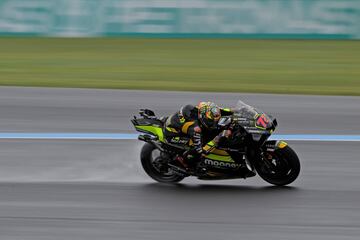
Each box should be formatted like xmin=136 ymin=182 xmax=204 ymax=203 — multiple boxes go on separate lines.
xmin=131 ymin=101 xmax=300 ymax=186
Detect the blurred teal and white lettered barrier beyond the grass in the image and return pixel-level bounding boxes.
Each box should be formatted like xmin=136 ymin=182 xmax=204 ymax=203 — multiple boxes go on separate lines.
xmin=0 ymin=0 xmax=360 ymax=39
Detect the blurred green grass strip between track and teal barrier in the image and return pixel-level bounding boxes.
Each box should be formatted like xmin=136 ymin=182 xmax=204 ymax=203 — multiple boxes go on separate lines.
xmin=0 ymin=38 xmax=360 ymax=95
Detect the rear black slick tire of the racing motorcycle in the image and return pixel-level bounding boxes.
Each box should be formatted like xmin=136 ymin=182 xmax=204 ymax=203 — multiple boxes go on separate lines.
xmin=140 ymin=143 xmax=184 ymax=183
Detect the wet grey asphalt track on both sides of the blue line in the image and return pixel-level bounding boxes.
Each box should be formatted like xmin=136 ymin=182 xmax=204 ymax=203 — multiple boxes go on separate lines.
xmin=0 ymin=87 xmax=360 ymax=240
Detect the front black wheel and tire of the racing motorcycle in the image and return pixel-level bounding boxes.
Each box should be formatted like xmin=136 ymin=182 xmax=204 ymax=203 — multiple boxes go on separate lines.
xmin=255 ymin=146 xmax=300 ymax=186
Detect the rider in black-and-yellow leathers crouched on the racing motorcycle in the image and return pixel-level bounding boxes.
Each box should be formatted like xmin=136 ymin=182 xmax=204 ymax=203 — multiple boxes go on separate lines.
xmin=164 ymin=102 xmax=233 ymax=169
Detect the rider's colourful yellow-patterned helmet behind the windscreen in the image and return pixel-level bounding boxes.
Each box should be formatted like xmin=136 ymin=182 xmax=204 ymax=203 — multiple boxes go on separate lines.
xmin=197 ymin=102 xmax=221 ymax=129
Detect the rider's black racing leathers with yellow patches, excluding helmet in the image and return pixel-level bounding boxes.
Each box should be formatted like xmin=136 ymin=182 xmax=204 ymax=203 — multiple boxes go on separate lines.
xmin=164 ymin=105 xmax=232 ymax=155
